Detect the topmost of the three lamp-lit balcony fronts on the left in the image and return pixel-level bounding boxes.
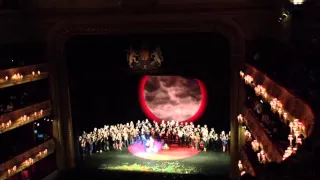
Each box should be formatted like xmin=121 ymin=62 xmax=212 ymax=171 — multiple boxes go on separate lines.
xmin=0 ymin=64 xmax=49 ymax=88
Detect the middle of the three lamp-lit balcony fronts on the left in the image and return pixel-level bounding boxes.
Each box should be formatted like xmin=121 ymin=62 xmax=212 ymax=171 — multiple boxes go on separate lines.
xmin=0 ymin=101 xmax=51 ymax=134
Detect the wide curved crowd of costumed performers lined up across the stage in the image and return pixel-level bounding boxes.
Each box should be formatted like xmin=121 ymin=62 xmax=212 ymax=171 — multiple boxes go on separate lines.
xmin=79 ymin=119 xmax=230 ymax=156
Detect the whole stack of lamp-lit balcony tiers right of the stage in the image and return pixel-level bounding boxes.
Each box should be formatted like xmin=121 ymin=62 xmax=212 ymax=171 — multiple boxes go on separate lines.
xmin=238 ymin=64 xmax=315 ymax=176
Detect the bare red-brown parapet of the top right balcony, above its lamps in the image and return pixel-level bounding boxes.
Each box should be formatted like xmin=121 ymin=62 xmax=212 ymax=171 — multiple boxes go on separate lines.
xmin=243 ymin=64 xmax=315 ymax=137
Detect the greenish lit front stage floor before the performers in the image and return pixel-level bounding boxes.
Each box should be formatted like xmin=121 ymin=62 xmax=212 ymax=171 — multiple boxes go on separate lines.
xmin=81 ymin=148 xmax=230 ymax=176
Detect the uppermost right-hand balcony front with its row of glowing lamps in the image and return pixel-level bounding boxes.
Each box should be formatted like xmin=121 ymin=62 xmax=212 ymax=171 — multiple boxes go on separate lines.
xmin=243 ymin=64 xmax=315 ymax=137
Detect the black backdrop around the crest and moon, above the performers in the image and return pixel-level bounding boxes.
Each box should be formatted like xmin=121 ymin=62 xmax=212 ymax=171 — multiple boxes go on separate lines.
xmin=66 ymin=33 xmax=230 ymax=138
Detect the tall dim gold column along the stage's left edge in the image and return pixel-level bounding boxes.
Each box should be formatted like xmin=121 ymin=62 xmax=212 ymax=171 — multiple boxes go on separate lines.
xmin=48 ymin=35 xmax=75 ymax=170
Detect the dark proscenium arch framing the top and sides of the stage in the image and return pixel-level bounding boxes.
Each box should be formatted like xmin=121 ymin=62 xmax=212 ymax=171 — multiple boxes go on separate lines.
xmin=47 ymin=16 xmax=245 ymax=179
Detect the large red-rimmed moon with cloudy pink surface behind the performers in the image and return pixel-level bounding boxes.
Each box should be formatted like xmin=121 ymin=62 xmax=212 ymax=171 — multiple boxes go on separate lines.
xmin=139 ymin=76 xmax=207 ymax=122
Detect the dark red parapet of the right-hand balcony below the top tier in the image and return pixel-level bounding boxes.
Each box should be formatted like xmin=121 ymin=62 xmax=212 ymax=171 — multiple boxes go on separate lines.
xmin=243 ymin=108 xmax=282 ymax=162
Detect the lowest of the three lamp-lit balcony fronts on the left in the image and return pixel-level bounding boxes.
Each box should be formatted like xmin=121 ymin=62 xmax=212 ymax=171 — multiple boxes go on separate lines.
xmin=0 ymin=139 xmax=55 ymax=179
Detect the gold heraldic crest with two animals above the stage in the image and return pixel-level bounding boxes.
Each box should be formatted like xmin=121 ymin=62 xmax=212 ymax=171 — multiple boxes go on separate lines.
xmin=127 ymin=47 xmax=163 ymax=70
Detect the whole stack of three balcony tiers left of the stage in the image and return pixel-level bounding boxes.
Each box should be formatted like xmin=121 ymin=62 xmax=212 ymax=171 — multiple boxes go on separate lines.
xmin=0 ymin=41 xmax=56 ymax=180
